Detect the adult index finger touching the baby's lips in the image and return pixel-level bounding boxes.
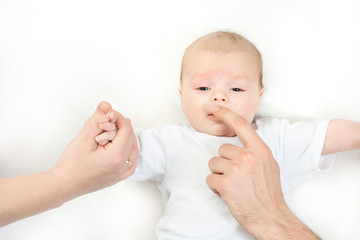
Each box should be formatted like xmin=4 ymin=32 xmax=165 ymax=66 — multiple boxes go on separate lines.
xmin=213 ymin=107 xmax=265 ymax=148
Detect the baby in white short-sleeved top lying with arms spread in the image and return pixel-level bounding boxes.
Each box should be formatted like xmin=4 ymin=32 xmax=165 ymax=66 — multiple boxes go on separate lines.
xmin=96 ymin=32 xmax=360 ymax=239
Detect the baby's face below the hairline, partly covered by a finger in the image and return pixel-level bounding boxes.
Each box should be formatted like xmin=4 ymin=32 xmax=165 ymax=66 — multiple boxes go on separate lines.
xmin=180 ymin=49 xmax=263 ymax=137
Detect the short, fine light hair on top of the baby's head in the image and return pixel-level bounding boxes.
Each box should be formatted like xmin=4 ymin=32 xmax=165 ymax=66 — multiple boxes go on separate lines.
xmin=180 ymin=31 xmax=263 ymax=89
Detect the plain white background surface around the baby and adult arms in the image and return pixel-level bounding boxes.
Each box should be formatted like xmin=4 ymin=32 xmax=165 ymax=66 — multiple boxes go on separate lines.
xmin=0 ymin=0 xmax=360 ymax=240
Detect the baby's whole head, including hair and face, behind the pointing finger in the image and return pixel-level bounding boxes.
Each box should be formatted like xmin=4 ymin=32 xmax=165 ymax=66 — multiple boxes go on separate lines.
xmin=179 ymin=32 xmax=264 ymax=137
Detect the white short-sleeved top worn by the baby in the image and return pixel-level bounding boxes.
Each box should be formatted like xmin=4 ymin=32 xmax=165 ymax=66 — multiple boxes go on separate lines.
xmin=130 ymin=119 xmax=335 ymax=240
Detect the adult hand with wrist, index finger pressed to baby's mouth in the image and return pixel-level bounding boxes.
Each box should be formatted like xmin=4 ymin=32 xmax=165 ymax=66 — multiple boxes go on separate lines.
xmin=207 ymin=108 xmax=319 ymax=239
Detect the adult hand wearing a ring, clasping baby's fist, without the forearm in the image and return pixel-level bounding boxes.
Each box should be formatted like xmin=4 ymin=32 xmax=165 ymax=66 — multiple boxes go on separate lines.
xmin=53 ymin=102 xmax=138 ymax=197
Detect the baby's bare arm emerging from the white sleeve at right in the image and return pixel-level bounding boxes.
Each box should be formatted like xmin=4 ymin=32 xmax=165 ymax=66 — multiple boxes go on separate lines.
xmin=321 ymin=119 xmax=360 ymax=155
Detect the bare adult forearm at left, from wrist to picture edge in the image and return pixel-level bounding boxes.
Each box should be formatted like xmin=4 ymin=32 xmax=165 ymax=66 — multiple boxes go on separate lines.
xmin=0 ymin=171 xmax=74 ymax=226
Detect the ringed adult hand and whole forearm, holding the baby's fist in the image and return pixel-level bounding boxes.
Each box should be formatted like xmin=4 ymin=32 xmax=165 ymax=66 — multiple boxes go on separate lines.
xmin=0 ymin=102 xmax=138 ymax=226
